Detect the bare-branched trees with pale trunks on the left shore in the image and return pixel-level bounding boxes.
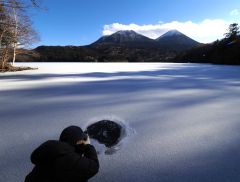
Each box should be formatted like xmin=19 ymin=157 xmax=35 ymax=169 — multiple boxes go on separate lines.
xmin=0 ymin=0 xmax=39 ymax=70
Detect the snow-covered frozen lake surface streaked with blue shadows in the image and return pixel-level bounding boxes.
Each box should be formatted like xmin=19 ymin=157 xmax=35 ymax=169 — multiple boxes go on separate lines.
xmin=0 ymin=63 xmax=240 ymax=182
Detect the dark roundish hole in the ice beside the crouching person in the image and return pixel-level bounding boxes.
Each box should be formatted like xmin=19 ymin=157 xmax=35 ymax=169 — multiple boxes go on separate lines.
xmin=86 ymin=120 xmax=125 ymax=148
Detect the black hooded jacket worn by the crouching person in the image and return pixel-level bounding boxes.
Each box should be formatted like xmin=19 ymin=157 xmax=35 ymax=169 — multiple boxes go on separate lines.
xmin=25 ymin=140 xmax=99 ymax=182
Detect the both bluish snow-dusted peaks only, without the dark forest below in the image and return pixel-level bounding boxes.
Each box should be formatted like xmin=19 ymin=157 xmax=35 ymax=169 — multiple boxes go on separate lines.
xmin=93 ymin=30 xmax=200 ymax=52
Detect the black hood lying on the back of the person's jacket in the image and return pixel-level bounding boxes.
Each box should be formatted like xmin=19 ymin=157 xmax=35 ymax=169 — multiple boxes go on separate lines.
xmin=31 ymin=140 xmax=75 ymax=165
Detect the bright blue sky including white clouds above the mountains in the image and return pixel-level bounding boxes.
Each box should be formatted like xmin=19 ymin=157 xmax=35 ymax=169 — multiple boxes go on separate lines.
xmin=31 ymin=0 xmax=240 ymax=46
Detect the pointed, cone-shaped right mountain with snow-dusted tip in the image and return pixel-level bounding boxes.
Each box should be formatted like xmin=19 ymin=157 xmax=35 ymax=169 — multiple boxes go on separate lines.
xmin=156 ymin=30 xmax=201 ymax=51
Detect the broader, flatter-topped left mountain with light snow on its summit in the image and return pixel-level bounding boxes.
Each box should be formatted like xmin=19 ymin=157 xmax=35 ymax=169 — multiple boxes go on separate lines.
xmin=91 ymin=30 xmax=156 ymax=47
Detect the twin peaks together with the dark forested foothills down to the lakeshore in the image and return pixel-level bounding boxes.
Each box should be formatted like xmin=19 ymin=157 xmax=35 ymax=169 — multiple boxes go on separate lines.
xmin=17 ymin=30 xmax=204 ymax=62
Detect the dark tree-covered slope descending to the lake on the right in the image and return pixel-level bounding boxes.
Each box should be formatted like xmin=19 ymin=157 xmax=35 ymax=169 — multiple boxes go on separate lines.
xmin=173 ymin=23 xmax=240 ymax=65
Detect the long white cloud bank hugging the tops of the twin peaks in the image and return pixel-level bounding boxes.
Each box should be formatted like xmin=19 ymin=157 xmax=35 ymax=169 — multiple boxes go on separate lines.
xmin=102 ymin=19 xmax=231 ymax=43
